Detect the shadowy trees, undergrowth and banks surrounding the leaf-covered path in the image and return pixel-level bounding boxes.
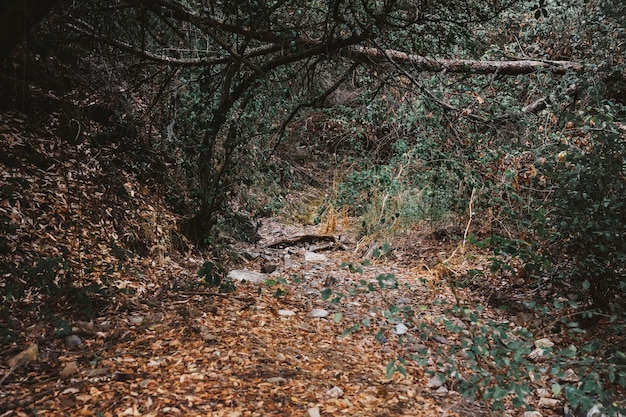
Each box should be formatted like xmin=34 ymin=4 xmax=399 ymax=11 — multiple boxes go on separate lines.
xmin=0 ymin=0 xmax=626 ymax=415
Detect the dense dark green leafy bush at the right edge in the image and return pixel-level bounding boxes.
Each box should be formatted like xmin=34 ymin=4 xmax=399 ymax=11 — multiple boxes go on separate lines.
xmin=550 ymin=107 xmax=626 ymax=310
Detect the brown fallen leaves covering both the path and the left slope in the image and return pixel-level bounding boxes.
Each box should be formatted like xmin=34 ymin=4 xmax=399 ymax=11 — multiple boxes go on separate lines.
xmin=0 ymin=113 xmax=490 ymax=416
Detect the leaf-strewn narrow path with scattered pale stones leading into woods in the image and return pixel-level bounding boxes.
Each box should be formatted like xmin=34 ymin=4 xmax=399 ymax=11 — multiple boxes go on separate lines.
xmin=0 ymin=216 xmax=485 ymax=417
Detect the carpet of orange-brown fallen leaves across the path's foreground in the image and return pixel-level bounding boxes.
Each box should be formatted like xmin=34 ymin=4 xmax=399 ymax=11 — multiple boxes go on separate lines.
xmin=0 ymin=247 xmax=486 ymax=416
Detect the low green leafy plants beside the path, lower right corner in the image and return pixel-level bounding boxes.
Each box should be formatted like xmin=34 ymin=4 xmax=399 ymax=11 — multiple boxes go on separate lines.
xmin=321 ymin=264 xmax=626 ymax=415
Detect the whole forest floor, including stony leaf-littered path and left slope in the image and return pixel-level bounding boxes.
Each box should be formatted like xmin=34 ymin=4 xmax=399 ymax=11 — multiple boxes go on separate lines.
xmin=0 ymin=109 xmax=552 ymax=417
